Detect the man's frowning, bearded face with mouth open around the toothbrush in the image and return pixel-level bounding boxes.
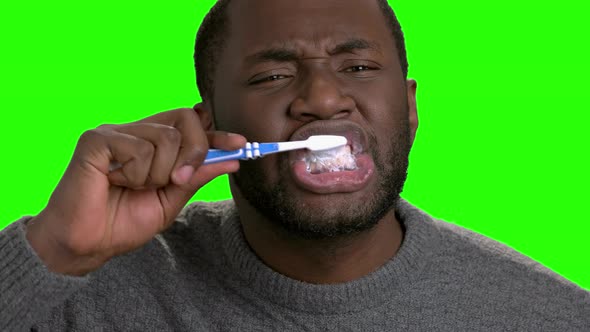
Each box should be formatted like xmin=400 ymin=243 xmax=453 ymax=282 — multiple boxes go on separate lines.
xmin=212 ymin=0 xmax=417 ymax=238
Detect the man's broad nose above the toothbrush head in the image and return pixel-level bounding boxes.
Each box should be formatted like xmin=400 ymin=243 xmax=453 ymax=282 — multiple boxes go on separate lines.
xmin=289 ymin=69 xmax=356 ymax=122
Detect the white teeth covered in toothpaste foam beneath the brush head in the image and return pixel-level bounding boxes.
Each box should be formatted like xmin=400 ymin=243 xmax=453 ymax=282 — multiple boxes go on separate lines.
xmin=303 ymin=145 xmax=357 ymax=174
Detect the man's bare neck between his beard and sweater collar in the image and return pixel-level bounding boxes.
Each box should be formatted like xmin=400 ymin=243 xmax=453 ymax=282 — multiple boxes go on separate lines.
xmin=234 ymin=196 xmax=403 ymax=284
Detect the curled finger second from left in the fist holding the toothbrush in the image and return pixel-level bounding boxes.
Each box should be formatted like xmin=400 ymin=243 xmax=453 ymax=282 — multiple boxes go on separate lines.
xmin=113 ymin=123 xmax=182 ymax=188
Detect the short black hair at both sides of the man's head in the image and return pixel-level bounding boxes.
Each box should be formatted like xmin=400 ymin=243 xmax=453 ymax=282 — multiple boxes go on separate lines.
xmin=194 ymin=0 xmax=408 ymax=101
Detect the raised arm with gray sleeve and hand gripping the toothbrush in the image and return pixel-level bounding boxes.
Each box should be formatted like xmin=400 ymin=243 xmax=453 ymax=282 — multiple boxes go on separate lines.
xmin=0 ymin=108 xmax=246 ymax=331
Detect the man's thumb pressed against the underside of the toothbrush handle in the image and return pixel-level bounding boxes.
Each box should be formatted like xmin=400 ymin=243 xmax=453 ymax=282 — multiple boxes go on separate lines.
xmin=160 ymin=160 xmax=240 ymax=227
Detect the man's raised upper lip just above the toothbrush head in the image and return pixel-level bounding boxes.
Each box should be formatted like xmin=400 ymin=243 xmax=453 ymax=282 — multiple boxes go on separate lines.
xmin=289 ymin=120 xmax=368 ymax=155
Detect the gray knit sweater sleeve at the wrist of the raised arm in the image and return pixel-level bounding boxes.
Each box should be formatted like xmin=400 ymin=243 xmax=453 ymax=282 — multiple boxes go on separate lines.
xmin=0 ymin=217 xmax=89 ymax=331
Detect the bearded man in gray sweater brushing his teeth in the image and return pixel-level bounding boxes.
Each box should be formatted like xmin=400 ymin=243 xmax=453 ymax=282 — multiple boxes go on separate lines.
xmin=0 ymin=0 xmax=590 ymax=331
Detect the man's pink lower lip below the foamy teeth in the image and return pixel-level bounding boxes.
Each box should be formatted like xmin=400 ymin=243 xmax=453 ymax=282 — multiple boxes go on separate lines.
xmin=291 ymin=154 xmax=375 ymax=194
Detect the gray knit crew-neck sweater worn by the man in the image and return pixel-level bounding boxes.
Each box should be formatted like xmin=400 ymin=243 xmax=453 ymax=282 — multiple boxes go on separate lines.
xmin=0 ymin=201 xmax=590 ymax=331
